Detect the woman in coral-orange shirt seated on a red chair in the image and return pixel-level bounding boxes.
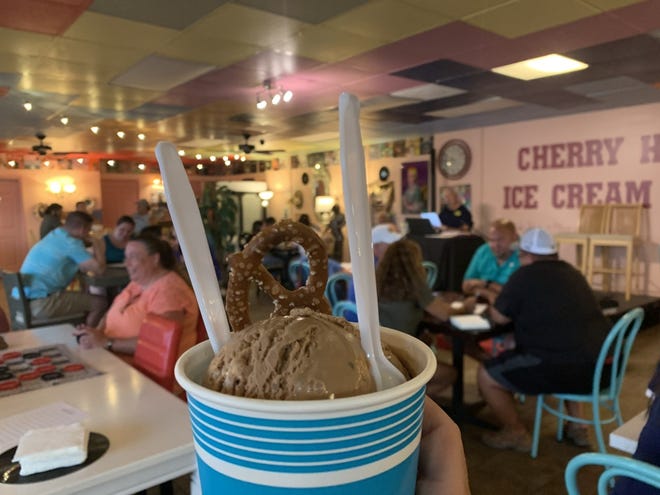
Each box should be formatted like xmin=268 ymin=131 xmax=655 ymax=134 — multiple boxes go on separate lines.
xmin=75 ymin=235 xmax=199 ymax=362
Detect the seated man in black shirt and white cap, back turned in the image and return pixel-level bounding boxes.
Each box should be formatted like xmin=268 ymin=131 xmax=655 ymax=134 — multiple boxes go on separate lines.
xmin=477 ymin=228 xmax=611 ymax=452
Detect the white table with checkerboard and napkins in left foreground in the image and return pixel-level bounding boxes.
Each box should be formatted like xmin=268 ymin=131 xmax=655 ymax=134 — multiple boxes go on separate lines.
xmin=0 ymin=325 xmax=196 ymax=495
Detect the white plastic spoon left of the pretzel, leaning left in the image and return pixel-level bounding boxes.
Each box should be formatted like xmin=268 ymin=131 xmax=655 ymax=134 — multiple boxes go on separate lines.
xmin=156 ymin=141 xmax=229 ymax=354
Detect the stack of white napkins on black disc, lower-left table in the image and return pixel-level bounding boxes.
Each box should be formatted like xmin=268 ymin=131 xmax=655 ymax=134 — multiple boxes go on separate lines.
xmin=12 ymin=423 xmax=89 ymax=476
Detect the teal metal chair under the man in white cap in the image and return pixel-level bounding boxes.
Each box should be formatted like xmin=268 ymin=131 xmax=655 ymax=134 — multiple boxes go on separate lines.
xmin=531 ymin=308 xmax=644 ymax=457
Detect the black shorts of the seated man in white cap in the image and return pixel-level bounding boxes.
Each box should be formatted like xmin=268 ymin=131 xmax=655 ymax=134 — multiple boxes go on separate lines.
xmin=484 ymin=350 xmax=594 ymax=395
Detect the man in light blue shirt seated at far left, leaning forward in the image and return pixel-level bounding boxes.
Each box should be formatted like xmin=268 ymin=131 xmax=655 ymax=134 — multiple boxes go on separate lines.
xmin=20 ymin=211 xmax=107 ymax=325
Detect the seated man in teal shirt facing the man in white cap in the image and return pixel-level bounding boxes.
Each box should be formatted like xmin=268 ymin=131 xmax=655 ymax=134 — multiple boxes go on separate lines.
xmin=463 ymin=219 xmax=520 ymax=304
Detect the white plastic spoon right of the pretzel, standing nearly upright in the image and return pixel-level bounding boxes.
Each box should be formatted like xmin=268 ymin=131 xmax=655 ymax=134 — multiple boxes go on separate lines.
xmin=339 ymin=93 xmax=405 ymax=390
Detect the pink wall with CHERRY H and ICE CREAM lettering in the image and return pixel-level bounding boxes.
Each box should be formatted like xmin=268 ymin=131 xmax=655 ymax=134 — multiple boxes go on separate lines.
xmin=435 ymin=104 xmax=660 ymax=294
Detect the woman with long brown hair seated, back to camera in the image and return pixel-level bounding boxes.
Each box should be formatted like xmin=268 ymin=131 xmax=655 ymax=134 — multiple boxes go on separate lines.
xmin=376 ymin=239 xmax=466 ymax=398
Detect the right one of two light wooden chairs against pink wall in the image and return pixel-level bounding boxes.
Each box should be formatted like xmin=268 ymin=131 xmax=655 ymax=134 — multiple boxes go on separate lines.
xmin=587 ymin=204 xmax=643 ymax=301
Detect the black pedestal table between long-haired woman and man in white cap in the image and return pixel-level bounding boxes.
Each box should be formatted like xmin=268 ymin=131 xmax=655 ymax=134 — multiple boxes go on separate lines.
xmin=420 ymin=313 xmax=511 ymax=428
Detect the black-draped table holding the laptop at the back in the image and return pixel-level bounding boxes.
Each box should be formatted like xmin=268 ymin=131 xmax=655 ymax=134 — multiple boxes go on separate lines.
xmin=407 ymin=234 xmax=484 ymax=292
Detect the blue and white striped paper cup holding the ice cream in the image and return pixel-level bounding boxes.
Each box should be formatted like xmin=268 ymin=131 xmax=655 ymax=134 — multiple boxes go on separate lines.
xmin=175 ymin=328 xmax=436 ymax=495
